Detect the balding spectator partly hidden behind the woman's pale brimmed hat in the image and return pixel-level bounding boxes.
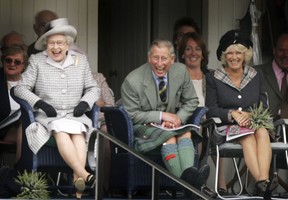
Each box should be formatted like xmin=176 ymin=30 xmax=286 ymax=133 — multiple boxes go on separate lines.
xmin=28 ymin=10 xmax=58 ymax=56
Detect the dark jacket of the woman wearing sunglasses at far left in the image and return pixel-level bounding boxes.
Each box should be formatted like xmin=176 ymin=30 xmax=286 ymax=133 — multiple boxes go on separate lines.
xmin=0 ymin=68 xmax=11 ymax=121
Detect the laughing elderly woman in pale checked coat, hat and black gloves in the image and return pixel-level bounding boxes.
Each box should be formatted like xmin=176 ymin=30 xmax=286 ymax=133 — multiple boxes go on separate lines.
xmin=15 ymin=18 xmax=100 ymax=198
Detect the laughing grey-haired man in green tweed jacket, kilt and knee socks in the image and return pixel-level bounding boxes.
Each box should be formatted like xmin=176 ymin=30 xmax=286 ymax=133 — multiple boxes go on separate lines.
xmin=121 ymin=40 xmax=209 ymax=196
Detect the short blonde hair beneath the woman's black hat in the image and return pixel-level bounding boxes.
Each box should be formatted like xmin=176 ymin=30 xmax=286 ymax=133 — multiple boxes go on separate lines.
xmin=220 ymin=44 xmax=253 ymax=66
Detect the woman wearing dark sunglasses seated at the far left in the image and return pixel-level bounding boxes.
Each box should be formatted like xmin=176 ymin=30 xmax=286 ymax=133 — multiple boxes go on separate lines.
xmin=0 ymin=45 xmax=28 ymax=161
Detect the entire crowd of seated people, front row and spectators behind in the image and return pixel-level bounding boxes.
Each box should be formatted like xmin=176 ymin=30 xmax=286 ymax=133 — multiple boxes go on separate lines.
xmin=0 ymin=10 xmax=288 ymax=199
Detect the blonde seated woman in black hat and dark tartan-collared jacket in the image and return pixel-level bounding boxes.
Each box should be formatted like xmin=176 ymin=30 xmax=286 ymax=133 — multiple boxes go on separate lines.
xmin=206 ymin=30 xmax=277 ymax=199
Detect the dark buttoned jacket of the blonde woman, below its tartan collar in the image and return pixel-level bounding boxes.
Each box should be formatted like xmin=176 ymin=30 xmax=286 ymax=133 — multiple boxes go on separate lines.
xmin=206 ymin=67 xmax=267 ymax=124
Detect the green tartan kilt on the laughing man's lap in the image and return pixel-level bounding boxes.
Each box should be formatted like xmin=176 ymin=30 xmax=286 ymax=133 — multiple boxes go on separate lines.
xmin=133 ymin=124 xmax=201 ymax=153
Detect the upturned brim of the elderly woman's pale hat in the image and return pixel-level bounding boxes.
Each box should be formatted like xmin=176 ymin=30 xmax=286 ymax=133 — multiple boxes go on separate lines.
xmin=34 ymin=25 xmax=77 ymax=50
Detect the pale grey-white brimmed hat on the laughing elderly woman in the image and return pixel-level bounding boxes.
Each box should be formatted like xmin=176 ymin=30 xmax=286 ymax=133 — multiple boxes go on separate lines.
xmin=34 ymin=18 xmax=77 ymax=50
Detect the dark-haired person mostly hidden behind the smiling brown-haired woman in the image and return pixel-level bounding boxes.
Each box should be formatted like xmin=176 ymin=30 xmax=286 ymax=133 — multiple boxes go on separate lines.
xmin=173 ymin=17 xmax=201 ymax=62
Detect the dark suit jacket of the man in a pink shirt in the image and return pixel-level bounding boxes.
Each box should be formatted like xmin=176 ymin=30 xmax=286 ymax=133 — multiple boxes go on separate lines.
xmin=254 ymin=62 xmax=283 ymax=118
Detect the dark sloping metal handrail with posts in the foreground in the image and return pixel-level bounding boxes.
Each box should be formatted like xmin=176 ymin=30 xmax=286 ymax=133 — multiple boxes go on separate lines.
xmin=94 ymin=131 xmax=211 ymax=200
